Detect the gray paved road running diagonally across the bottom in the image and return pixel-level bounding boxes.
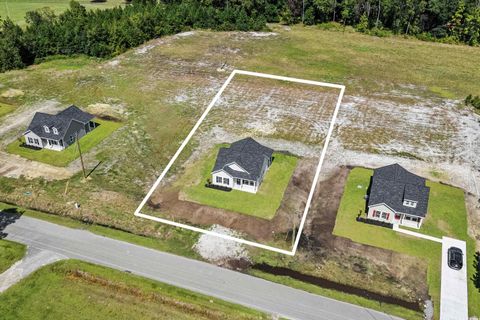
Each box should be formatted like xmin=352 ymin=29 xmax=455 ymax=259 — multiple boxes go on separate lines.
xmin=4 ymin=216 xmax=398 ymax=320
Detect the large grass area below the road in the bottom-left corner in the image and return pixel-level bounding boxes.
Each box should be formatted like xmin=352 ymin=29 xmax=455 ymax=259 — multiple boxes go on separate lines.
xmin=0 ymin=260 xmax=267 ymax=320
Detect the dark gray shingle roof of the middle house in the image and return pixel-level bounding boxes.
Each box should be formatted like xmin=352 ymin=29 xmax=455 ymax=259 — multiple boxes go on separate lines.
xmin=212 ymin=138 xmax=273 ymax=181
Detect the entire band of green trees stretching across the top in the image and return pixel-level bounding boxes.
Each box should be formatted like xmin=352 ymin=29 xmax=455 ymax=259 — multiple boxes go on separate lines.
xmin=0 ymin=0 xmax=480 ymax=72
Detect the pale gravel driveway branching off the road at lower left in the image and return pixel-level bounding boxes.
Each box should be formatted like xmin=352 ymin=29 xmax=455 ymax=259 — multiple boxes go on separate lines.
xmin=0 ymin=247 xmax=67 ymax=292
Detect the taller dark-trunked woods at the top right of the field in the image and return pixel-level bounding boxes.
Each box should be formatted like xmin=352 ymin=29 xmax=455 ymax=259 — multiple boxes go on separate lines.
xmin=280 ymin=0 xmax=480 ymax=46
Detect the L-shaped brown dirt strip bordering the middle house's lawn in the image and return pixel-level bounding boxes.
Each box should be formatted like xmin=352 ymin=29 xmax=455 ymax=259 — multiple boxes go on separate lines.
xmin=148 ymin=159 xmax=316 ymax=241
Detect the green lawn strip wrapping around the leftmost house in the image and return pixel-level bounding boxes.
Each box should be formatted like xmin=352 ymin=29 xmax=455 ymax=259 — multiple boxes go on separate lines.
xmin=7 ymin=119 xmax=122 ymax=167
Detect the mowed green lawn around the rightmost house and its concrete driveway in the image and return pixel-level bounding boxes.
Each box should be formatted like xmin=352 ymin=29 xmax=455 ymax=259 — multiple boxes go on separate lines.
xmin=333 ymin=168 xmax=480 ymax=319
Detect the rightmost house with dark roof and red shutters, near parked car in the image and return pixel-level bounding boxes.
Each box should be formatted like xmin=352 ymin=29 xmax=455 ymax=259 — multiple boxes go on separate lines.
xmin=367 ymin=164 xmax=430 ymax=229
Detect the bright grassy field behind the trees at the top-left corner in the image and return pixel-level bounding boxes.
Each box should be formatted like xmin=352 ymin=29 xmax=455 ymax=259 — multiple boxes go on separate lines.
xmin=0 ymin=0 xmax=125 ymax=25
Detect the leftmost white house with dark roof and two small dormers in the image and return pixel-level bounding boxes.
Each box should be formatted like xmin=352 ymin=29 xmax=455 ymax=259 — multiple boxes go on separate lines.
xmin=23 ymin=105 xmax=97 ymax=151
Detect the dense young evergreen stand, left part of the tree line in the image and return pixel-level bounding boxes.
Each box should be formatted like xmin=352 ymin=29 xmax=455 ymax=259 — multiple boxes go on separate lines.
xmin=0 ymin=0 xmax=266 ymax=72
